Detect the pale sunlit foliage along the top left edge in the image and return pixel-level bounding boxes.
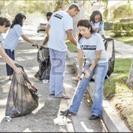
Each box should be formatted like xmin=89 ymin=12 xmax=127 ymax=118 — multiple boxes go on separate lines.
xmin=0 ymin=0 xmax=55 ymax=16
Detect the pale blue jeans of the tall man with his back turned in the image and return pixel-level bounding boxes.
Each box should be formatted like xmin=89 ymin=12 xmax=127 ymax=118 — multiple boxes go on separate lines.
xmin=49 ymin=49 xmax=66 ymax=96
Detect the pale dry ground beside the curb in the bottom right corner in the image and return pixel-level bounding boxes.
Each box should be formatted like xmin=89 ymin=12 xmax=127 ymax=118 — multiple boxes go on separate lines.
xmin=111 ymin=84 xmax=133 ymax=131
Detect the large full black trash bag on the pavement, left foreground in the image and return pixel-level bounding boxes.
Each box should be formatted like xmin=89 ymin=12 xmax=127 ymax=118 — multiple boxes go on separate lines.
xmin=5 ymin=66 xmax=38 ymax=118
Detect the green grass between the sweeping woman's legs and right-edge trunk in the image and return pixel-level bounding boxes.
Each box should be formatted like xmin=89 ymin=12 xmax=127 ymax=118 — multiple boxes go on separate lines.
xmin=104 ymin=58 xmax=131 ymax=100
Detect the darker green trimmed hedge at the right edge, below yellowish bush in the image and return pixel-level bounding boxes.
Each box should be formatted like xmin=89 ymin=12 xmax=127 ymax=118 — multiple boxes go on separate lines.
xmin=113 ymin=22 xmax=133 ymax=37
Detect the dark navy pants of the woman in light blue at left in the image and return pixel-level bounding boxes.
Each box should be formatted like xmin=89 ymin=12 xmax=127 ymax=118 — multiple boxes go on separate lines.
xmin=5 ymin=49 xmax=15 ymax=76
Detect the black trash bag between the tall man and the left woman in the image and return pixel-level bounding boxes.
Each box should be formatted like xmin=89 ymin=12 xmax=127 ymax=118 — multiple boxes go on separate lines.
xmin=35 ymin=47 xmax=51 ymax=80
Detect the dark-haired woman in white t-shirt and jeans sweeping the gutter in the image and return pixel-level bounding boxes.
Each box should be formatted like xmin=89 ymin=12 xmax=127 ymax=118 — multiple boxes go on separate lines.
xmin=61 ymin=19 xmax=108 ymax=120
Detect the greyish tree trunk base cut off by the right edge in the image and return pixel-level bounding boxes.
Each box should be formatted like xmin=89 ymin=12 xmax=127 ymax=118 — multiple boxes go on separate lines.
xmin=127 ymin=63 xmax=133 ymax=89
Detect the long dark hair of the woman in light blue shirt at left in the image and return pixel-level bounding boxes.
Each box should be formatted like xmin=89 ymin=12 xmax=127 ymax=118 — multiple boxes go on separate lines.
xmin=11 ymin=13 xmax=26 ymax=28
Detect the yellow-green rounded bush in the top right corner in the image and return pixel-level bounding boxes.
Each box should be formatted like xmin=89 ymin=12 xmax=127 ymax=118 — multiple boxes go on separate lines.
xmin=113 ymin=4 xmax=133 ymax=19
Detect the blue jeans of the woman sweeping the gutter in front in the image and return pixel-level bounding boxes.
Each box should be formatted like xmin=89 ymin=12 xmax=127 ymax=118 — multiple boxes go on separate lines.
xmin=69 ymin=63 xmax=108 ymax=116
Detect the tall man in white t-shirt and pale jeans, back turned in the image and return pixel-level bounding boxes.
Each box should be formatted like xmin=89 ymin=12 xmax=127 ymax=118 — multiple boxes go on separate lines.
xmin=47 ymin=4 xmax=80 ymax=99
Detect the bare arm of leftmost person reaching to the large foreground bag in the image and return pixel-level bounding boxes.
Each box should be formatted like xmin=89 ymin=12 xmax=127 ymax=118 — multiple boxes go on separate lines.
xmin=0 ymin=46 xmax=21 ymax=73
